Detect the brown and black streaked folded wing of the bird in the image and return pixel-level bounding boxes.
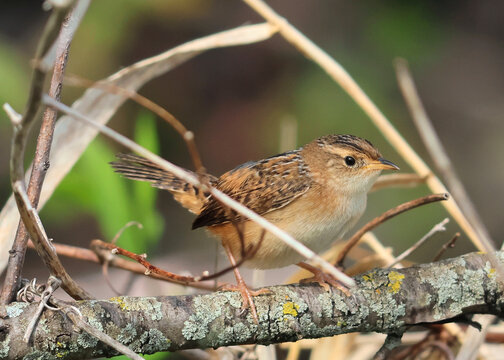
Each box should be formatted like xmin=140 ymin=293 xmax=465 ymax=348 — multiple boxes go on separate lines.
xmin=193 ymin=150 xmax=312 ymax=229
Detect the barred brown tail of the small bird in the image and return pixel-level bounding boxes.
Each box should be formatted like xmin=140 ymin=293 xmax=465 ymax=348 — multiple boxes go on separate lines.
xmin=110 ymin=154 xmax=217 ymax=215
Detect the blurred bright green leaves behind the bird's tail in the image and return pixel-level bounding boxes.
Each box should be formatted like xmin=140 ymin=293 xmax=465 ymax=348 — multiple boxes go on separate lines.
xmin=43 ymin=112 xmax=163 ymax=253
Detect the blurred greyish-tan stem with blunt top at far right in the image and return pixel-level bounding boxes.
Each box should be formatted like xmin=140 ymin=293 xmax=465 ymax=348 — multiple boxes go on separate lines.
xmin=395 ymin=59 xmax=495 ymax=253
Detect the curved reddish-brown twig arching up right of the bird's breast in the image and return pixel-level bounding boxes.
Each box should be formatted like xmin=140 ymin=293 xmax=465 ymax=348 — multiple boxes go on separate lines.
xmin=336 ymin=193 xmax=449 ymax=267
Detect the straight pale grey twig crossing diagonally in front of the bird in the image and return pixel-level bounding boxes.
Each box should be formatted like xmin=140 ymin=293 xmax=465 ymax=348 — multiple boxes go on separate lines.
xmin=44 ymin=96 xmax=355 ymax=286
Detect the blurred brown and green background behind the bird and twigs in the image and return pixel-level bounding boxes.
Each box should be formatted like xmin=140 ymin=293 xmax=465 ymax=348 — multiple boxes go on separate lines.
xmin=0 ymin=0 xmax=504 ymax=358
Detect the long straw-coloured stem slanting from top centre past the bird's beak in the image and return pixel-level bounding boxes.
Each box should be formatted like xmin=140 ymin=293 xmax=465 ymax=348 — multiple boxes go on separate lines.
xmin=243 ymin=0 xmax=485 ymax=250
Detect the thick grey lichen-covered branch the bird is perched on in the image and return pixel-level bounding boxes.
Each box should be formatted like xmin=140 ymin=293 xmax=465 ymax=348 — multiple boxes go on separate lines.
xmin=0 ymin=252 xmax=504 ymax=359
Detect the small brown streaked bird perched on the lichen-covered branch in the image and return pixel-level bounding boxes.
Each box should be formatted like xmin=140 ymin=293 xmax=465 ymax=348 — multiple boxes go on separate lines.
xmin=111 ymin=135 xmax=399 ymax=318
